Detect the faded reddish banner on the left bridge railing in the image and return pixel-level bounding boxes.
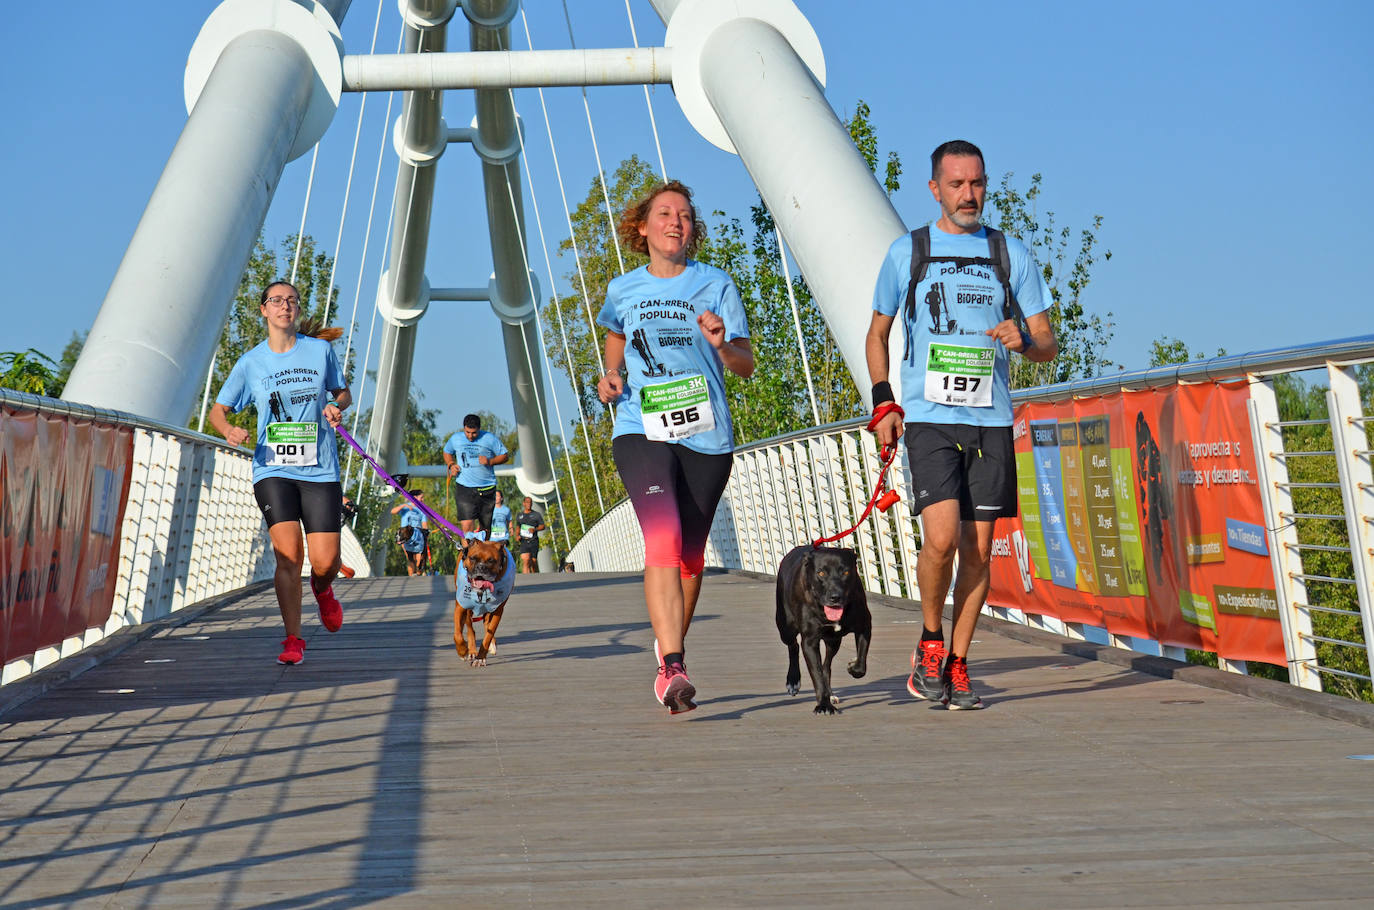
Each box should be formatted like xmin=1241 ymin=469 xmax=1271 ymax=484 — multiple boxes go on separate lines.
xmin=0 ymin=408 xmax=133 ymax=664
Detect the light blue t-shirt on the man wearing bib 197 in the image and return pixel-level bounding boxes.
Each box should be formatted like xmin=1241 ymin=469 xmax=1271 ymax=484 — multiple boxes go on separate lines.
xmin=872 ymin=224 xmax=1052 ymax=426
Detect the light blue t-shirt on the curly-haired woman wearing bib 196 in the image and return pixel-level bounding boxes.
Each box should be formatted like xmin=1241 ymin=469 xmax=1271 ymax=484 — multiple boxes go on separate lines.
xmin=596 ymin=260 xmax=749 ymax=455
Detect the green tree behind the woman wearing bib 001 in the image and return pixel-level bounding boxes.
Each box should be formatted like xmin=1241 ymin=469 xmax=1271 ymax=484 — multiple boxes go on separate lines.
xmin=197 ymin=234 xmax=353 ymax=436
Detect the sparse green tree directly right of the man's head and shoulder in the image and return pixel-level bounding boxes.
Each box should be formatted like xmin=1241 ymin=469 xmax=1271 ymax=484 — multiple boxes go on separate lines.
xmin=988 ymin=173 xmax=1113 ymax=389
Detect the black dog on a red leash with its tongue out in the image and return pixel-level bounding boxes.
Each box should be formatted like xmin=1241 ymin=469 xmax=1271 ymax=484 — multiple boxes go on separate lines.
xmin=778 ymin=546 xmax=872 ymax=713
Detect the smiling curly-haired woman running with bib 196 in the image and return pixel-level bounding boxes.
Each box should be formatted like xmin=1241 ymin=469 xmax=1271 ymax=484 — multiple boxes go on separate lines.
xmin=596 ymin=180 xmax=754 ymax=713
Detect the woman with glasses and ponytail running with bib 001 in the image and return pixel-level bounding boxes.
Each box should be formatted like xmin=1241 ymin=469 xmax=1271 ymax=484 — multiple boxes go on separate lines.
xmin=210 ymin=282 xmax=353 ymax=664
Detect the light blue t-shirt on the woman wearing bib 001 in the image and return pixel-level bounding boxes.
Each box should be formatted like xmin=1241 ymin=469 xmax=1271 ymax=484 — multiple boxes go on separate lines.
xmin=214 ymin=334 xmax=346 ymax=484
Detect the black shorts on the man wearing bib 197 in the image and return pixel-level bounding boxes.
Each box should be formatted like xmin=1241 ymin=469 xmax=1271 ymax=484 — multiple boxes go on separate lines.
xmin=905 ymin=423 xmax=1017 ymax=521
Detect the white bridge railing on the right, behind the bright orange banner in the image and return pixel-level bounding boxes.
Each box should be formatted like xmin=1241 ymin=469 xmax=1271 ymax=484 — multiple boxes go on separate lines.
xmin=567 ymin=335 xmax=1374 ymax=697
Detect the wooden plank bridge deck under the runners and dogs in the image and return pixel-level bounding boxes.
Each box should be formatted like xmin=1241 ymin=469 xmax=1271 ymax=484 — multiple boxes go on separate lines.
xmin=0 ymin=575 xmax=1374 ymax=907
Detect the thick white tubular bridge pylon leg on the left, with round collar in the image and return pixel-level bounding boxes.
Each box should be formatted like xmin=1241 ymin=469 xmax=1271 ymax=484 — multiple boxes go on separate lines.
xmin=65 ymin=0 xmax=349 ymax=423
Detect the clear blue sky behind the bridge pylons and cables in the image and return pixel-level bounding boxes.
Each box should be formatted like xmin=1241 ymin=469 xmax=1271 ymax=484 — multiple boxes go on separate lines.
xmin=0 ymin=0 xmax=1374 ymax=439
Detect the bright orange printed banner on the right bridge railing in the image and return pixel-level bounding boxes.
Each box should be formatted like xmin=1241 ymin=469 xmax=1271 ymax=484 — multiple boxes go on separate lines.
xmin=988 ymin=384 xmax=1286 ymax=665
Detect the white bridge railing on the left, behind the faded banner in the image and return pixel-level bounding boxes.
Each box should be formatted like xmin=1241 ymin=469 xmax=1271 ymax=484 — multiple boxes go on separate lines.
xmin=0 ymin=389 xmax=367 ymax=685
